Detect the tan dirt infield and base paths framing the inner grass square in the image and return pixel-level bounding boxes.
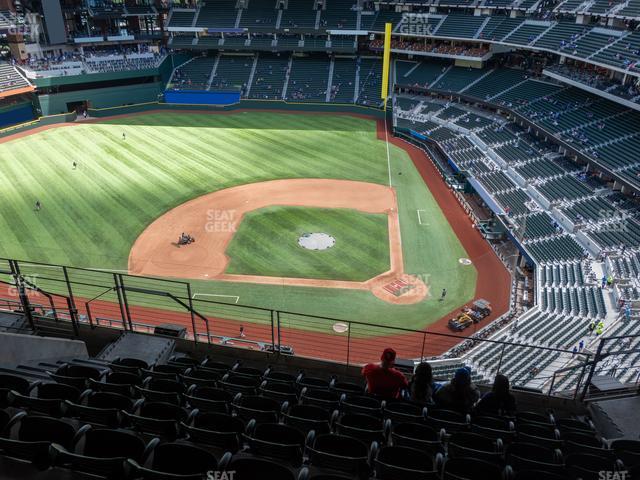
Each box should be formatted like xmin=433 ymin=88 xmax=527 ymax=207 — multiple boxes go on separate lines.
xmin=129 ymin=179 xmax=427 ymax=304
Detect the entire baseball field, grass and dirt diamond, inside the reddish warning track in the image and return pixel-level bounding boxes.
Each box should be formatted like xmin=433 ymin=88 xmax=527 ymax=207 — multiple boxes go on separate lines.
xmin=0 ymin=111 xmax=484 ymax=334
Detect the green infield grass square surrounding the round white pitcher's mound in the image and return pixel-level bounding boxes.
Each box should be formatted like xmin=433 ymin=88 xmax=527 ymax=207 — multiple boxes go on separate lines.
xmin=226 ymin=207 xmax=390 ymax=282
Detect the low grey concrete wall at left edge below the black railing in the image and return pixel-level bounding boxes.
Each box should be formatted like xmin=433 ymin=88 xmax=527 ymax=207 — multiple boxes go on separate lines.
xmin=0 ymin=333 xmax=88 ymax=367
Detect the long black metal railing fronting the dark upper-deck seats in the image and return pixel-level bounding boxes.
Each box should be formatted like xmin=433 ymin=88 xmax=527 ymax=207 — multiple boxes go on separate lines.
xmin=0 ymin=258 xmax=640 ymax=398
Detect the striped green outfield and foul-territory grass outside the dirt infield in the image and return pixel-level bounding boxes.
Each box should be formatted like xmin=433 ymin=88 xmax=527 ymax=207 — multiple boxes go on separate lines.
xmin=0 ymin=112 xmax=476 ymax=328
